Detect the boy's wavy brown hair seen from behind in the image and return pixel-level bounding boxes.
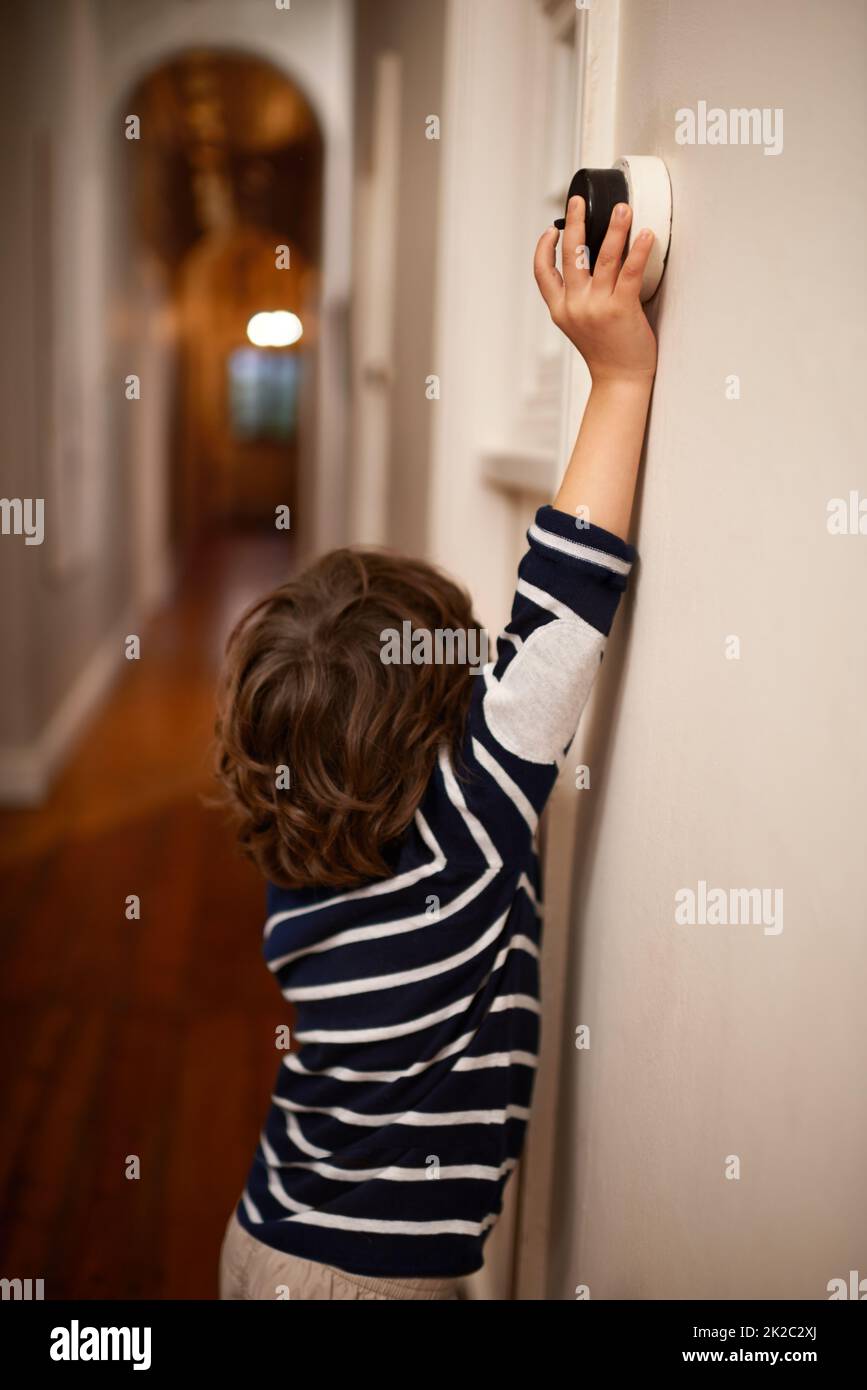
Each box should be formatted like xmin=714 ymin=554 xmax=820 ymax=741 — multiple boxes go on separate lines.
xmin=215 ymin=548 xmax=478 ymax=888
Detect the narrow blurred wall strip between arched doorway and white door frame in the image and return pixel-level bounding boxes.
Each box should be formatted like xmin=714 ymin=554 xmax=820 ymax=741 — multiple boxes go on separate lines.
xmin=350 ymin=0 xmax=446 ymax=553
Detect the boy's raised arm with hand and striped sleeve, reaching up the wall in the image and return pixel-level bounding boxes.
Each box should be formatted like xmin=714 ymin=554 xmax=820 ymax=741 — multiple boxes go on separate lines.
xmin=452 ymin=197 xmax=656 ymax=856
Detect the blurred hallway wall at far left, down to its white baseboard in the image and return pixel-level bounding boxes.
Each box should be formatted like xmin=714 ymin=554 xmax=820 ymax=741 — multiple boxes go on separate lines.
xmin=0 ymin=0 xmax=132 ymax=802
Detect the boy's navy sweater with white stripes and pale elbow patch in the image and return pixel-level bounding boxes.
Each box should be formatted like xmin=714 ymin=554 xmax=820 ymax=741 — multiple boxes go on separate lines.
xmin=238 ymin=506 xmax=635 ymax=1277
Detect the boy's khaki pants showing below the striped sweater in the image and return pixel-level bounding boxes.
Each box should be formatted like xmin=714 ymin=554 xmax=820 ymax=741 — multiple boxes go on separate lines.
xmin=220 ymin=1212 xmax=463 ymax=1301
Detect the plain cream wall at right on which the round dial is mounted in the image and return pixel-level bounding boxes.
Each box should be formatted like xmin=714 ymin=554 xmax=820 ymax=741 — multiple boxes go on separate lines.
xmin=549 ymin=0 xmax=867 ymax=1298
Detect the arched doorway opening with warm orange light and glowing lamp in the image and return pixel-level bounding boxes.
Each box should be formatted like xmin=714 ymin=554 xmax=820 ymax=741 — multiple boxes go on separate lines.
xmin=124 ymin=49 xmax=324 ymax=575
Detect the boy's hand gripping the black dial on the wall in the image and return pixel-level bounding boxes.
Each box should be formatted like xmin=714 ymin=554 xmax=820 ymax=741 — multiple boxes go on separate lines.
xmin=534 ymin=195 xmax=656 ymax=382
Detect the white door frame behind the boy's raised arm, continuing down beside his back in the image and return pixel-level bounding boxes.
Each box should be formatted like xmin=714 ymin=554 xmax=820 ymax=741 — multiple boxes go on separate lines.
xmin=427 ymin=0 xmax=620 ymax=1300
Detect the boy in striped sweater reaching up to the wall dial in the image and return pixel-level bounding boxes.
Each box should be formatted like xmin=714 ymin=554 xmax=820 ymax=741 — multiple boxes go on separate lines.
xmin=218 ymin=197 xmax=656 ymax=1300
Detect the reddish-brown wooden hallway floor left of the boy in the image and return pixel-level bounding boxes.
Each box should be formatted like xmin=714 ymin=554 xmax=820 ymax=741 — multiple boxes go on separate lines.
xmin=0 ymin=537 xmax=290 ymax=1298
